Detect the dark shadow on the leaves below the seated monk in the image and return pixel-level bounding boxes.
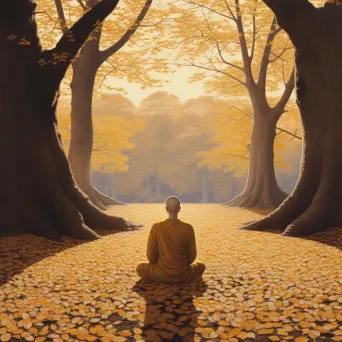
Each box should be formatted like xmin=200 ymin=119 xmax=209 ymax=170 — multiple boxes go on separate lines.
xmin=133 ymin=280 xmax=207 ymax=342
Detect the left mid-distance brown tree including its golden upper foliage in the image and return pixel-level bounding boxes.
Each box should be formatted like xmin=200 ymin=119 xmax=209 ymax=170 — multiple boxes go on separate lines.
xmin=40 ymin=0 xmax=158 ymax=209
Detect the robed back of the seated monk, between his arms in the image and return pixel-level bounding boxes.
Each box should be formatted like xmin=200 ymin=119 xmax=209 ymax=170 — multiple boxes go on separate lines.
xmin=153 ymin=219 xmax=193 ymax=273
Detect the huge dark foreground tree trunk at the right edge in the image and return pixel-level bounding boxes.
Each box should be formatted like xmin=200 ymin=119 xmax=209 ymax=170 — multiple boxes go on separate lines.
xmin=244 ymin=0 xmax=342 ymax=236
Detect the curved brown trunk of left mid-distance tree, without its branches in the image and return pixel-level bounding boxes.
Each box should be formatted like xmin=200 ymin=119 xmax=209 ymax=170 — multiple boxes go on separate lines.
xmin=69 ymin=24 xmax=123 ymax=210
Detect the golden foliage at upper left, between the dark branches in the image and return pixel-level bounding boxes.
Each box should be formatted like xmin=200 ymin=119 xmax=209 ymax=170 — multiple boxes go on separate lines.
xmin=37 ymin=0 xmax=168 ymax=96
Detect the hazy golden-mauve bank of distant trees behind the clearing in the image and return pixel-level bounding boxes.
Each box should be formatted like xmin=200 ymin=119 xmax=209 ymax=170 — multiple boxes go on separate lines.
xmin=84 ymin=92 xmax=300 ymax=202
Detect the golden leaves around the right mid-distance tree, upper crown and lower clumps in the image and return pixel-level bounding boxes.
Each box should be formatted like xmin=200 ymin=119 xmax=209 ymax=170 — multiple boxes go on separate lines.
xmin=146 ymin=0 xmax=301 ymax=176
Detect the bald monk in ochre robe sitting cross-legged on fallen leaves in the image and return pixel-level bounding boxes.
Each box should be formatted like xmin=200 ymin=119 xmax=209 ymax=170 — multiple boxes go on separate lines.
xmin=136 ymin=196 xmax=205 ymax=284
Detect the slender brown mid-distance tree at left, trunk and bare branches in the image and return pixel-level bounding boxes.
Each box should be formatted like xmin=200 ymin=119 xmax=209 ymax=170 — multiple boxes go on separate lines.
xmin=44 ymin=0 xmax=156 ymax=209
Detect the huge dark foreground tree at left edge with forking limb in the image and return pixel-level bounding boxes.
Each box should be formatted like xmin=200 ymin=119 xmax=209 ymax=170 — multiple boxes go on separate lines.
xmin=0 ymin=0 xmax=137 ymax=240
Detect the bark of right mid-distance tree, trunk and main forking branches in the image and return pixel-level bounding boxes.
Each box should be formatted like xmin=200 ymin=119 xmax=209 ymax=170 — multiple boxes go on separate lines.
xmin=224 ymin=12 xmax=301 ymax=208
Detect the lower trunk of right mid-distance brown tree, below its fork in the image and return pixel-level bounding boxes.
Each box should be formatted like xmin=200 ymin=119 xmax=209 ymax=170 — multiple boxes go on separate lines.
xmin=226 ymin=112 xmax=287 ymax=208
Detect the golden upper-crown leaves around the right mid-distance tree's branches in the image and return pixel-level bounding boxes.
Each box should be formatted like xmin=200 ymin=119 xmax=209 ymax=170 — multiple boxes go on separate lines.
xmin=156 ymin=0 xmax=293 ymax=97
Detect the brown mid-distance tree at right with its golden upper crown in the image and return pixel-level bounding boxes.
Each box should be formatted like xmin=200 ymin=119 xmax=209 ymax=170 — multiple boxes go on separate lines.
xmin=164 ymin=0 xmax=294 ymax=208
